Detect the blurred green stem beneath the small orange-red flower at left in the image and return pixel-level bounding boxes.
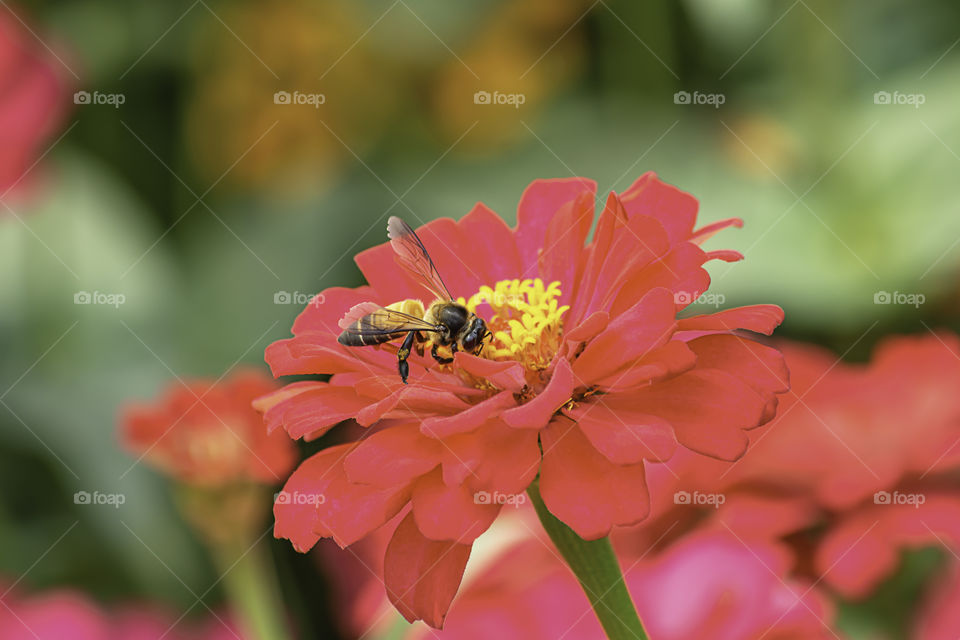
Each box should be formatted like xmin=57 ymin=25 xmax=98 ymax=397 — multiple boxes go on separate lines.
xmin=217 ymin=543 xmax=291 ymax=640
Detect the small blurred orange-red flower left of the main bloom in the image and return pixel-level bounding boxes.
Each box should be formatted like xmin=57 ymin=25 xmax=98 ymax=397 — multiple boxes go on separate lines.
xmin=120 ymin=369 xmax=297 ymax=487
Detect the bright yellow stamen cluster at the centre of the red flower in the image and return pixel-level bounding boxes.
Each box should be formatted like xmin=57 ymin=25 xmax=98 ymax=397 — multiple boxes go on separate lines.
xmin=460 ymin=278 xmax=569 ymax=370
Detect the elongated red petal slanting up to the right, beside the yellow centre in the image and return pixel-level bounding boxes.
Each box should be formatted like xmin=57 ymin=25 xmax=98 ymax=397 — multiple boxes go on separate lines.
xmin=573 ymin=288 xmax=676 ymax=384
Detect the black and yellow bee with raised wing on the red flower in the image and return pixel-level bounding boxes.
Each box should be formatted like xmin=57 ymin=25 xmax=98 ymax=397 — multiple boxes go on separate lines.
xmin=337 ymin=216 xmax=490 ymax=384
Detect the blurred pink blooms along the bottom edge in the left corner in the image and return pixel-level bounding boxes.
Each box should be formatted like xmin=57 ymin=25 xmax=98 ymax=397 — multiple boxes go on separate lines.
xmin=0 ymin=585 xmax=242 ymax=640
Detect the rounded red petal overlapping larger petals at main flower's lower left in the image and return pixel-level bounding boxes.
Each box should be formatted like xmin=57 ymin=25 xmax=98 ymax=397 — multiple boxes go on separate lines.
xmin=343 ymin=424 xmax=443 ymax=487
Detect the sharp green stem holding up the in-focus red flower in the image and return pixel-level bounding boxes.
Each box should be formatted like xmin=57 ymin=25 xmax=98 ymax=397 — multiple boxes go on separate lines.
xmin=527 ymin=479 xmax=647 ymax=640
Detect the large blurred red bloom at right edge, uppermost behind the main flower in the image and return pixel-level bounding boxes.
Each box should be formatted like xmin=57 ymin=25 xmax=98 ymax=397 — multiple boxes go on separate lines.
xmin=728 ymin=334 xmax=960 ymax=510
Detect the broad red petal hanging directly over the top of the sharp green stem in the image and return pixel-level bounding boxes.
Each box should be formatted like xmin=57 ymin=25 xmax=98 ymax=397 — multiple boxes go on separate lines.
xmin=540 ymin=418 xmax=650 ymax=540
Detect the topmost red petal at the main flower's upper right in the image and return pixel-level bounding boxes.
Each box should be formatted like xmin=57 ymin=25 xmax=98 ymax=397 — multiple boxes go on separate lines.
xmin=620 ymin=171 xmax=699 ymax=243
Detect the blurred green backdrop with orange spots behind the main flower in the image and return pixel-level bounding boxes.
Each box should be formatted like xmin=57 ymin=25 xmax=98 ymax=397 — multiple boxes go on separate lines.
xmin=0 ymin=0 xmax=960 ymax=629
